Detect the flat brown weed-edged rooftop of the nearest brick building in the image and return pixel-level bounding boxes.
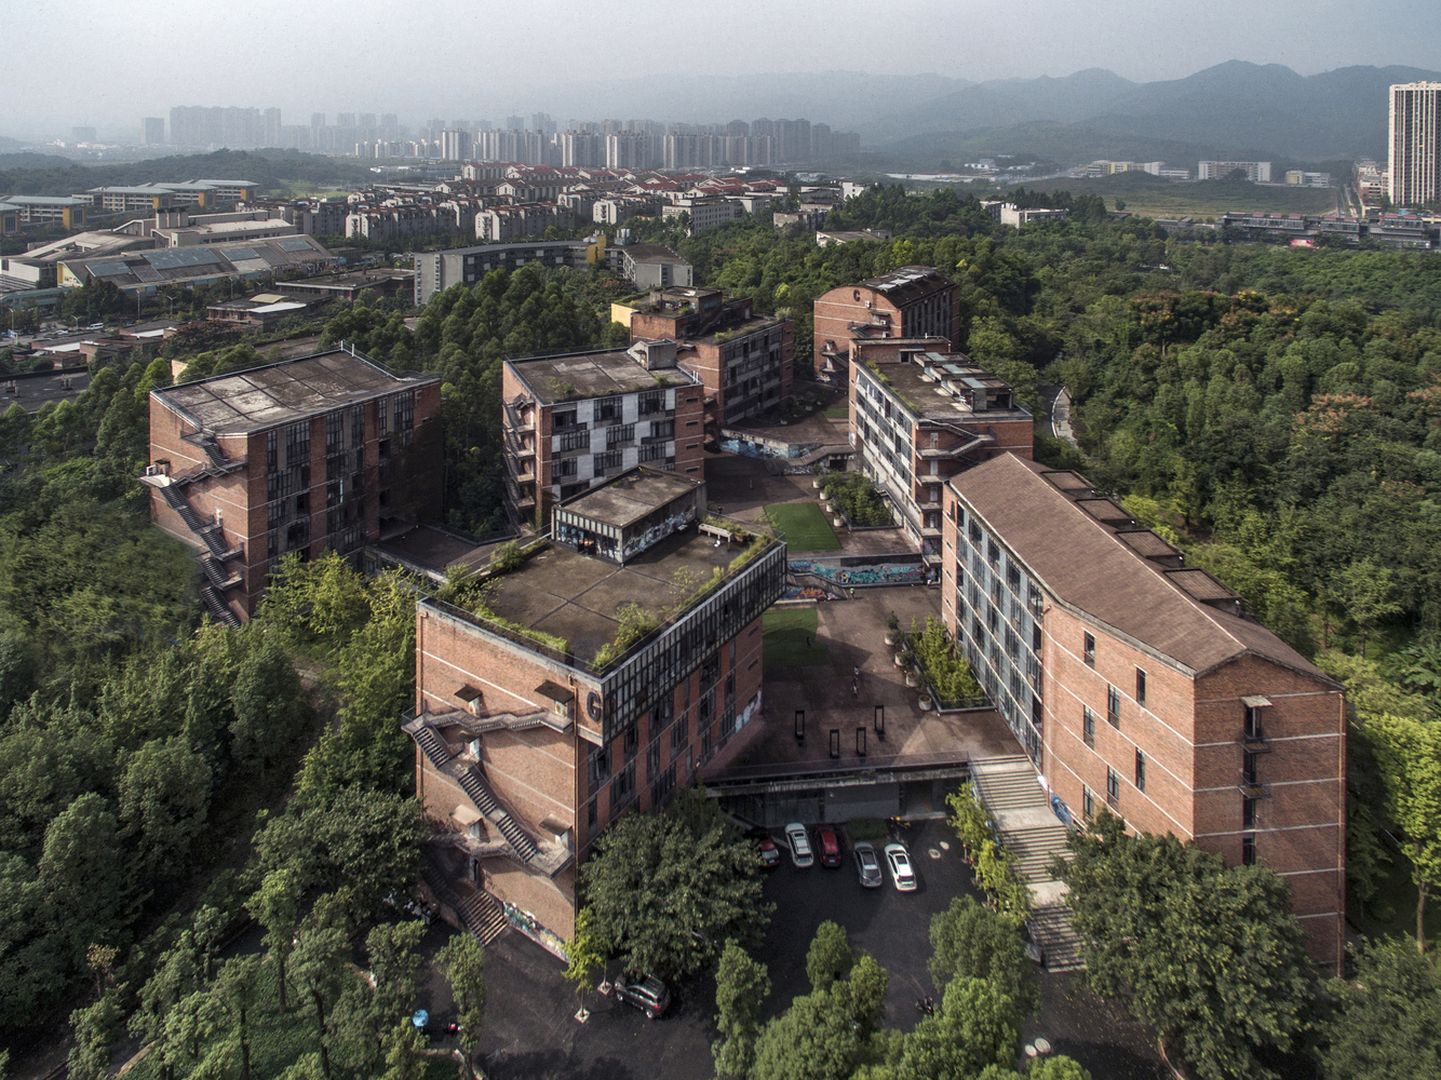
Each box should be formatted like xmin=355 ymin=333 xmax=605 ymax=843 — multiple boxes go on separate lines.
xmin=480 ymin=529 xmax=744 ymax=662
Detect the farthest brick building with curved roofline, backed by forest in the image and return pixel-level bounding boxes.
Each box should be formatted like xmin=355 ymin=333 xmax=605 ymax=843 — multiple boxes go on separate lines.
xmin=811 ymin=267 xmax=961 ymax=386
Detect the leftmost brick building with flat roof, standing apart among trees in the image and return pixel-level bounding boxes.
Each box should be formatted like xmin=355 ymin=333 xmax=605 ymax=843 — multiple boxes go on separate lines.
xmin=141 ymin=349 xmax=442 ymax=624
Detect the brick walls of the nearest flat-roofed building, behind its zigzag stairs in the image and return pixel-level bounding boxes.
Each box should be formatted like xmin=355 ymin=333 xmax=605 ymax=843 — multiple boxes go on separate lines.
xmin=415 ymin=604 xmax=762 ymax=939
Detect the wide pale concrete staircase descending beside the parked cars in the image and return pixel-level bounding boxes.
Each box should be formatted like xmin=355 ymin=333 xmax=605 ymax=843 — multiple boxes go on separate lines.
xmin=971 ymin=754 xmax=1085 ymax=972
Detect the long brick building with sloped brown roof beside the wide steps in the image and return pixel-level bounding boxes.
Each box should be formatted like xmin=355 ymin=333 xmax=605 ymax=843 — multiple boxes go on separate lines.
xmin=941 ymin=454 xmax=1346 ymax=970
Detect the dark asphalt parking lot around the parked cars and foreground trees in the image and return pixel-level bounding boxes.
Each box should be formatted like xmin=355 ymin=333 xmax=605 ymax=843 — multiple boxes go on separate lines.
xmin=421 ymin=820 xmax=1164 ymax=1080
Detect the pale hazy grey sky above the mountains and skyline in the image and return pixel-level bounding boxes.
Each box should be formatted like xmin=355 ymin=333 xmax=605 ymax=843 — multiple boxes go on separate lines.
xmin=8 ymin=0 xmax=1441 ymax=134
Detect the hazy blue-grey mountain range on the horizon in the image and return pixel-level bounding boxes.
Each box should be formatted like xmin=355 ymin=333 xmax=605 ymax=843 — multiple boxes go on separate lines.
xmin=546 ymin=61 xmax=1441 ymax=169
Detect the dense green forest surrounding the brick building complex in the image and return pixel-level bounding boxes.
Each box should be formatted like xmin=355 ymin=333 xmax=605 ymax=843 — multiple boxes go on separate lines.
xmin=0 ymin=183 xmax=1441 ymax=1077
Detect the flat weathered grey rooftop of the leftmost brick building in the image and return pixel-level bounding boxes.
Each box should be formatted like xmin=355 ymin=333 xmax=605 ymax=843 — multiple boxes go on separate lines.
xmin=151 ymin=349 xmax=435 ymax=435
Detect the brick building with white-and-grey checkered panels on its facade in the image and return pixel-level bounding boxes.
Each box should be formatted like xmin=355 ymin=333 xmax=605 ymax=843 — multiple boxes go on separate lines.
xmin=500 ymin=340 xmax=705 ymax=525
